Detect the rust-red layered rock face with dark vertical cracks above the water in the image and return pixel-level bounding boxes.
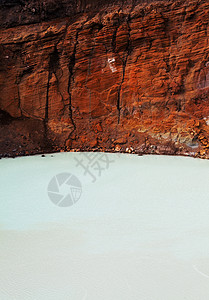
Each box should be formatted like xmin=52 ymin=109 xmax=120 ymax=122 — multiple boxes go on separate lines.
xmin=0 ymin=0 xmax=209 ymax=158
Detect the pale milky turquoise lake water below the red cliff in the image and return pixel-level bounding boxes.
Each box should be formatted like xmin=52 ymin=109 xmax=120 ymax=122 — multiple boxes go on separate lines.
xmin=0 ymin=153 xmax=209 ymax=300
